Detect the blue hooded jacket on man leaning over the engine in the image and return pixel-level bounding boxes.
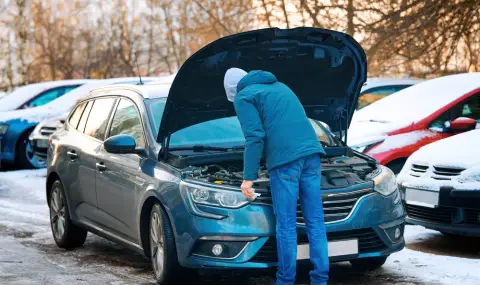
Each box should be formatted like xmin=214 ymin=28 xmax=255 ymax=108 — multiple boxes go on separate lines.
xmin=234 ymin=71 xmax=325 ymax=180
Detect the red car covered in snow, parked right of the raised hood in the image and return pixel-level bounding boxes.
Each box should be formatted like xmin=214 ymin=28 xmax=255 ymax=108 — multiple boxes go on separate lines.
xmin=348 ymin=73 xmax=480 ymax=173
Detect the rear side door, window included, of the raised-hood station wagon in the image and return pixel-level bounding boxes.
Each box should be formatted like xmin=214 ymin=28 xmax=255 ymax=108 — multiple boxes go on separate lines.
xmin=74 ymin=97 xmax=116 ymax=223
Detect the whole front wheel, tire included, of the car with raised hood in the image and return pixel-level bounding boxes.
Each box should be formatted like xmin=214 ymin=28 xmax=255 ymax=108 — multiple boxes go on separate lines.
xmin=149 ymin=203 xmax=191 ymax=285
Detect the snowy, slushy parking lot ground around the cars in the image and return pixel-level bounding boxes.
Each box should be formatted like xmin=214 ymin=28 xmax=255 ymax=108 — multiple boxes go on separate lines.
xmin=0 ymin=170 xmax=480 ymax=285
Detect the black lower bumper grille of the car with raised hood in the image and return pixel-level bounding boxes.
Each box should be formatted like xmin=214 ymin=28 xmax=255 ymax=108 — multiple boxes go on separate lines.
xmin=250 ymin=229 xmax=388 ymax=262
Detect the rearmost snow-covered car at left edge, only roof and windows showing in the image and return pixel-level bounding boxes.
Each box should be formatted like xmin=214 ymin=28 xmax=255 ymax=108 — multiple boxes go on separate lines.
xmin=0 ymin=79 xmax=92 ymax=112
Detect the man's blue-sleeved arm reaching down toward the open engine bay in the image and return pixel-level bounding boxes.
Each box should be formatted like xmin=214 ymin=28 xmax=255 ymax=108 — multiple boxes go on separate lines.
xmin=234 ymin=94 xmax=265 ymax=180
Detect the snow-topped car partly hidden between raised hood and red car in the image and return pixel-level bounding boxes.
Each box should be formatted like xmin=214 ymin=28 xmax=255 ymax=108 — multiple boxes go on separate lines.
xmin=357 ymin=77 xmax=424 ymax=110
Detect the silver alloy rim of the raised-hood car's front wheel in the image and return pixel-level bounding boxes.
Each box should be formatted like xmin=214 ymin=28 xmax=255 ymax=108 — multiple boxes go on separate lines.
xmin=150 ymin=212 xmax=165 ymax=277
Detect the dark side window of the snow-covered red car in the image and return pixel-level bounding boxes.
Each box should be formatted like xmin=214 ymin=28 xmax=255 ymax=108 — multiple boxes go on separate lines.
xmin=429 ymin=94 xmax=480 ymax=131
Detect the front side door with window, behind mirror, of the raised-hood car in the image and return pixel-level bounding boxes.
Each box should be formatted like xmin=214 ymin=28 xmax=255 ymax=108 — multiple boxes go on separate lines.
xmin=96 ymin=98 xmax=146 ymax=242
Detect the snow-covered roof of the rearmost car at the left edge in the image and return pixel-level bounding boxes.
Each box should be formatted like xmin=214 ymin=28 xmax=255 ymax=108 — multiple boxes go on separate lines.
xmin=0 ymin=79 xmax=91 ymax=111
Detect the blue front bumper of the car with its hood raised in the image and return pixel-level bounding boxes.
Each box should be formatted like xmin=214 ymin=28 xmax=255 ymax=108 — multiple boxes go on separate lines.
xmin=170 ymin=185 xmax=405 ymax=268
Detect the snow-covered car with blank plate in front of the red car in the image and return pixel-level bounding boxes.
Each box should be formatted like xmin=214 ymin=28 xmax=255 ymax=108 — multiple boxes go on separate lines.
xmin=397 ymin=129 xmax=480 ymax=236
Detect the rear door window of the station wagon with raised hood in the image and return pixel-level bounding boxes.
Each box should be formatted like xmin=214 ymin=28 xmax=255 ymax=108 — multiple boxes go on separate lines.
xmin=84 ymin=98 xmax=115 ymax=141
